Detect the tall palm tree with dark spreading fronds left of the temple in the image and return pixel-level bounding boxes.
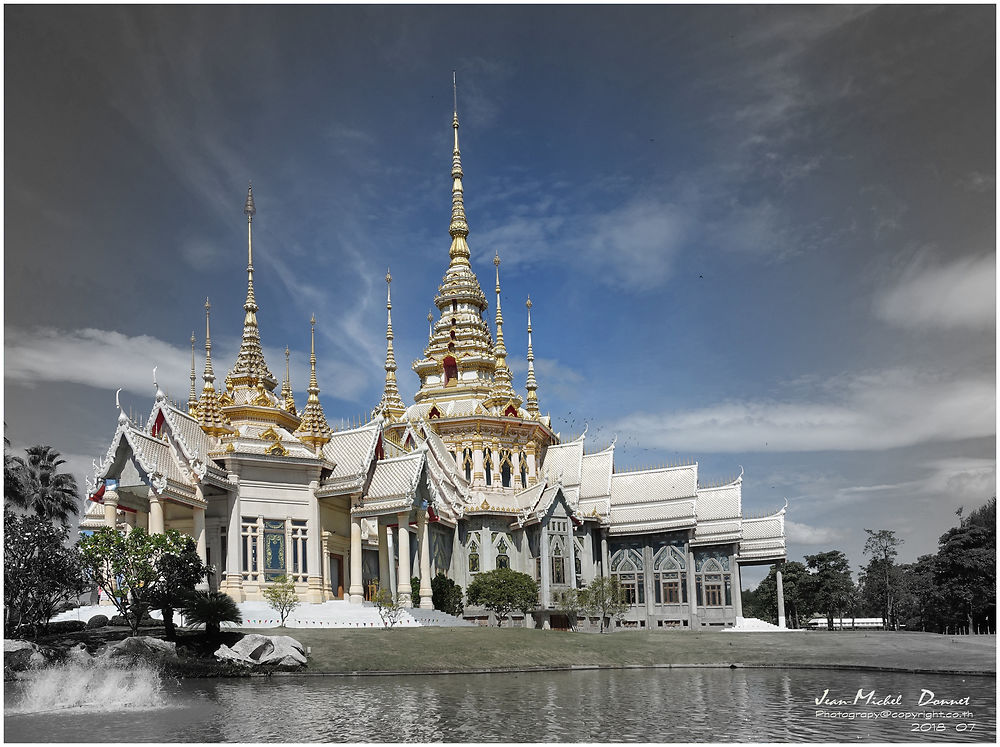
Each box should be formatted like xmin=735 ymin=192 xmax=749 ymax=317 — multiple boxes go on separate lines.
xmin=4 ymin=446 xmax=80 ymax=527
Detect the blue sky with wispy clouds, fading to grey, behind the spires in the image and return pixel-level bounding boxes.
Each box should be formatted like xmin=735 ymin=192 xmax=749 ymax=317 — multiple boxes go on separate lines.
xmin=4 ymin=6 xmax=996 ymax=582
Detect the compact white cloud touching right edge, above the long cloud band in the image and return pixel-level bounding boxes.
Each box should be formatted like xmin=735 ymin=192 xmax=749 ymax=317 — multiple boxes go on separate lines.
xmin=875 ymin=254 xmax=996 ymax=329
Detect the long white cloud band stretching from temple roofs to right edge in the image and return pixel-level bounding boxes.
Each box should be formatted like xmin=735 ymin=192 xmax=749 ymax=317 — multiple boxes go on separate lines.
xmin=616 ymin=369 xmax=996 ymax=452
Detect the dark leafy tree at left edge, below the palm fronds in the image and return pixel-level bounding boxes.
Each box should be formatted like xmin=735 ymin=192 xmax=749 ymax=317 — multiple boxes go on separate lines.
xmin=3 ymin=509 xmax=84 ymax=634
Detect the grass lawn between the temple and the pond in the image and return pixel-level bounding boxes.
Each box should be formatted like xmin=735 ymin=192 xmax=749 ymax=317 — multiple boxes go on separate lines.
xmin=247 ymin=628 xmax=996 ymax=674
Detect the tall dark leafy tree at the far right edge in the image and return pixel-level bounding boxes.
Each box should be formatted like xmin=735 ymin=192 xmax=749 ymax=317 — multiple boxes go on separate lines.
xmin=934 ymin=497 xmax=996 ymax=633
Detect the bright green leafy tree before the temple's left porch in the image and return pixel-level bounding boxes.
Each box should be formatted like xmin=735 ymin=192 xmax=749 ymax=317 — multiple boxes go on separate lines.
xmin=78 ymin=527 xmax=200 ymax=635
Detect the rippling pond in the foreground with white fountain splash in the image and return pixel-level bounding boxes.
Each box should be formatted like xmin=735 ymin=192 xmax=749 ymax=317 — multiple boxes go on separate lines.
xmin=4 ymin=666 xmax=996 ymax=742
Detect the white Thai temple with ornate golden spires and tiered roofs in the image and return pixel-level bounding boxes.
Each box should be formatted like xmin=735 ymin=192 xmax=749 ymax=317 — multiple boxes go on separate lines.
xmin=81 ymin=95 xmax=787 ymax=628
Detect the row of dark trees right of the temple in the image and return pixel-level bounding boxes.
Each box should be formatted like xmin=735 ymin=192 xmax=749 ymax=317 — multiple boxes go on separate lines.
xmin=743 ymin=496 xmax=997 ymax=634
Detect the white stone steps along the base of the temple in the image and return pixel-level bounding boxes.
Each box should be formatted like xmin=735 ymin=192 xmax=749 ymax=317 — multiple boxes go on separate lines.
xmin=52 ymin=600 xmax=473 ymax=629
